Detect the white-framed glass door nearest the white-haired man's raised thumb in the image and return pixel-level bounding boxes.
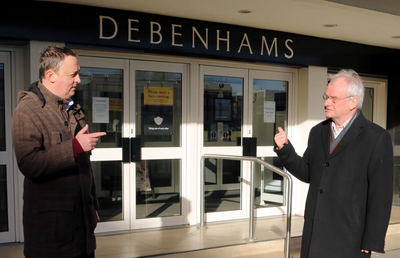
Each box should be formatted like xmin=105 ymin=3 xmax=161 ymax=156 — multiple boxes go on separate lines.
xmin=249 ymin=70 xmax=292 ymax=216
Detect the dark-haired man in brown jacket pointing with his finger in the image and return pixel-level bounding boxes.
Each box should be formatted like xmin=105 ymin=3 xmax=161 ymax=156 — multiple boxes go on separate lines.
xmin=12 ymin=46 xmax=105 ymax=258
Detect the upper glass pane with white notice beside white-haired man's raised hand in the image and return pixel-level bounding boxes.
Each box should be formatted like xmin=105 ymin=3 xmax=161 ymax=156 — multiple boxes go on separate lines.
xmin=253 ymin=79 xmax=288 ymax=146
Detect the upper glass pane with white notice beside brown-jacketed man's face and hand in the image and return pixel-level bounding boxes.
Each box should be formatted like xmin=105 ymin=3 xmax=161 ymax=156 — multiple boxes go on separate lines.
xmin=77 ymin=67 xmax=124 ymax=148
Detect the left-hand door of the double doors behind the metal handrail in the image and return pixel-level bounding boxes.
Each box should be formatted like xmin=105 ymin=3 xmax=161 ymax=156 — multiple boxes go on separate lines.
xmin=200 ymin=66 xmax=248 ymax=221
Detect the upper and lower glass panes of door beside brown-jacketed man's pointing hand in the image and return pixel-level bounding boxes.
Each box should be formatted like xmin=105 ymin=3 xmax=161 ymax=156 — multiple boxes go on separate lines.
xmin=74 ymin=67 xmax=124 ymax=222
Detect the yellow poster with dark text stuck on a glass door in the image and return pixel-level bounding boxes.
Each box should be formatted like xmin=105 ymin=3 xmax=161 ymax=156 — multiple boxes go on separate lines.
xmin=144 ymin=86 xmax=174 ymax=106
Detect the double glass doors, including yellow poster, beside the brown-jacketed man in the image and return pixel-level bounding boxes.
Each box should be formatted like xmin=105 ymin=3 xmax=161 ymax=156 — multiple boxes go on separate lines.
xmin=76 ymin=56 xmax=187 ymax=232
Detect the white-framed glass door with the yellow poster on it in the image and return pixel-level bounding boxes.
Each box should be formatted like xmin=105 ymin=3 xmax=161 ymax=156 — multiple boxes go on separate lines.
xmin=129 ymin=60 xmax=189 ymax=229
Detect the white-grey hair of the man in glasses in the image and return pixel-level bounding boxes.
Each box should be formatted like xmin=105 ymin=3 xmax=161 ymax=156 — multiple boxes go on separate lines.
xmin=329 ymin=69 xmax=365 ymax=109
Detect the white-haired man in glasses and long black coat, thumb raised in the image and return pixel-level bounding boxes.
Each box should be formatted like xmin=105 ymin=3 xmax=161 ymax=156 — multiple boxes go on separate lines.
xmin=274 ymin=70 xmax=393 ymax=258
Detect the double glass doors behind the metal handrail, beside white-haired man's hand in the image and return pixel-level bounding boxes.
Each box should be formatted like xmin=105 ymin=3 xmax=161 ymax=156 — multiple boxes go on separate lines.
xmin=200 ymin=66 xmax=295 ymax=221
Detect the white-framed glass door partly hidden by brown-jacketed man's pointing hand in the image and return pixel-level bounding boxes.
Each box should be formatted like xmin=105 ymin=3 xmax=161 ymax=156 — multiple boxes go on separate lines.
xmin=75 ymin=55 xmax=132 ymax=232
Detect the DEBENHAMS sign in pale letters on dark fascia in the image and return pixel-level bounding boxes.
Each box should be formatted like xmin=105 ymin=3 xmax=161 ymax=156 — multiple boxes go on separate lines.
xmin=98 ymin=15 xmax=295 ymax=61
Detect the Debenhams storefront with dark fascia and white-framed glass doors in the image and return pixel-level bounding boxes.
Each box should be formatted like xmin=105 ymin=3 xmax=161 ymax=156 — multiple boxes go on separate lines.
xmin=0 ymin=2 xmax=399 ymax=243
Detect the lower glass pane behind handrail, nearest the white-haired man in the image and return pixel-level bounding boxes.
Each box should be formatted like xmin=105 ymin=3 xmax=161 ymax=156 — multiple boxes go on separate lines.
xmin=254 ymin=157 xmax=286 ymax=208
